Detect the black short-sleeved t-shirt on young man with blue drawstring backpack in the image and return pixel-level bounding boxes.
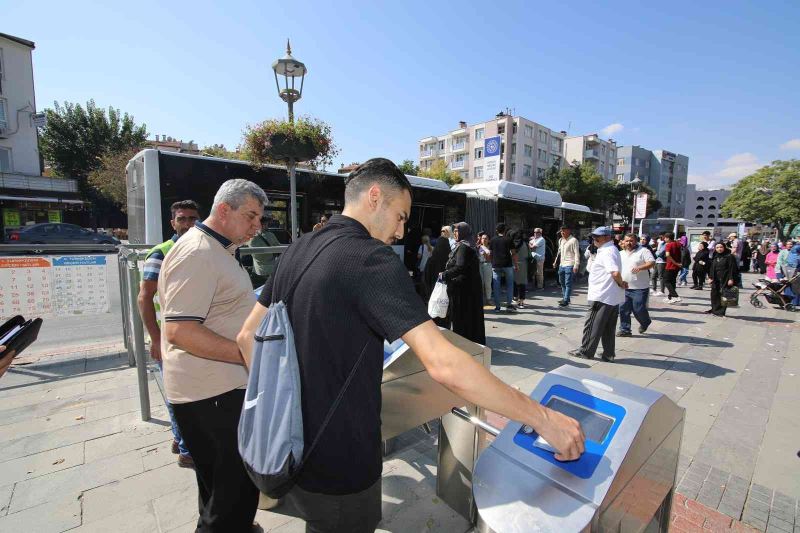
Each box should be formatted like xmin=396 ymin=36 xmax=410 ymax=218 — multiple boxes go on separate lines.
xmin=258 ymin=215 xmax=430 ymax=494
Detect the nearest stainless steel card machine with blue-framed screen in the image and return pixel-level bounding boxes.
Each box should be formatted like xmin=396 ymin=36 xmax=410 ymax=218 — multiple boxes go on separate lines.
xmin=473 ymin=365 xmax=684 ymax=533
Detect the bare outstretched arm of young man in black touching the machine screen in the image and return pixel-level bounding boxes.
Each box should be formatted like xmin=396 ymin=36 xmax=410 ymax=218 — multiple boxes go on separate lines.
xmin=403 ymin=321 xmax=586 ymax=461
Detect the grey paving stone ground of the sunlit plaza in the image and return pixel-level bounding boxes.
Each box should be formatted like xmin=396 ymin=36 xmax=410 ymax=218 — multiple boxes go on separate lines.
xmin=0 ymin=274 xmax=800 ymax=533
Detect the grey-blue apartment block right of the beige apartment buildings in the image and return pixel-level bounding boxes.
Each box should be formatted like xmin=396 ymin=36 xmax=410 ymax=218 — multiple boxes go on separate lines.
xmin=616 ymin=145 xmax=689 ymax=218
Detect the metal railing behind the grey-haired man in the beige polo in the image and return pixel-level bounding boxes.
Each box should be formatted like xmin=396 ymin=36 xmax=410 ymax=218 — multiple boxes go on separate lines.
xmin=117 ymin=244 xmax=288 ymax=421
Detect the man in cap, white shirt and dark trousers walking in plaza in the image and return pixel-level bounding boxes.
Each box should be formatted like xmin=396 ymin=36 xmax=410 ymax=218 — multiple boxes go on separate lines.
xmin=569 ymin=226 xmax=628 ymax=362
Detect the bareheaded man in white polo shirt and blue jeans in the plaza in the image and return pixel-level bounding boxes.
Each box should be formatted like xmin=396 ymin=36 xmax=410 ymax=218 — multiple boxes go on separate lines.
xmin=617 ymin=233 xmax=656 ymax=337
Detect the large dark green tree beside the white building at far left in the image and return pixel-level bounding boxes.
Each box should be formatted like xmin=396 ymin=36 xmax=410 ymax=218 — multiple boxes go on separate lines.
xmin=40 ymin=100 xmax=147 ymax=219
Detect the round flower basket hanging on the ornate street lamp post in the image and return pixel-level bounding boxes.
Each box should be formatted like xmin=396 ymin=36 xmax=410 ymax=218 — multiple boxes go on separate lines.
xmin=244 ymin=117 xmax=338 ymax=168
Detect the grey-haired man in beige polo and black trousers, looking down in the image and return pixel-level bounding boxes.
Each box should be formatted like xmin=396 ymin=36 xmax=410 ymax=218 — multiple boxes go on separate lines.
xmin=158 ymin=179 xmax=268 ymax=533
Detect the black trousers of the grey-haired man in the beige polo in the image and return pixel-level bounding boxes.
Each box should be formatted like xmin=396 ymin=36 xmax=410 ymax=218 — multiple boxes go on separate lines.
xmin=172 ymin=389 xmax=258 ymax=533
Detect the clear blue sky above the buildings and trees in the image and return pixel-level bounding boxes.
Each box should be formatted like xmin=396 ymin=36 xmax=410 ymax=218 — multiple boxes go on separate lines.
xmin=6 ymin=0 xmax=800 ymax=186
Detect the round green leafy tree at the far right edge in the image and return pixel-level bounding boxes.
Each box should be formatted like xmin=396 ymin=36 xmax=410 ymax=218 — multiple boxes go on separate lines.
xmin=721 ymin=159 xmax=800 ymax=240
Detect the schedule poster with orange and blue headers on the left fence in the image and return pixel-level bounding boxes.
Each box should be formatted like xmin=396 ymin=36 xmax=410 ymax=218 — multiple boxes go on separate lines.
xmin=0 ymin=255 xmax=109 ymax=319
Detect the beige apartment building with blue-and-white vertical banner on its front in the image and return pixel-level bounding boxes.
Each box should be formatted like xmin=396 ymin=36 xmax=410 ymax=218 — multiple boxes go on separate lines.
xmin=418 ymin=113 xmax=566 ymax=186
